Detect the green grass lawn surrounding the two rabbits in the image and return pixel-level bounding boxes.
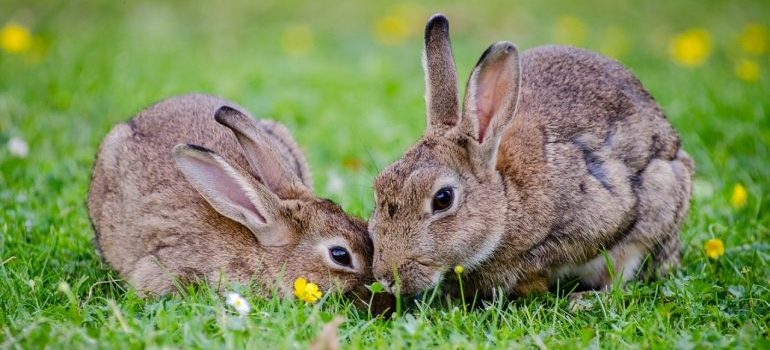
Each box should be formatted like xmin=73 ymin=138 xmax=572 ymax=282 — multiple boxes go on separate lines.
xmin=0 ymin=0 xmax=770 ymax=349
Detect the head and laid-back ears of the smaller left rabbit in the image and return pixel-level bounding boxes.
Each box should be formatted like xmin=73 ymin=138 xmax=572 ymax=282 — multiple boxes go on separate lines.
xmin=173 ymin=107 xmax=372 ymax=294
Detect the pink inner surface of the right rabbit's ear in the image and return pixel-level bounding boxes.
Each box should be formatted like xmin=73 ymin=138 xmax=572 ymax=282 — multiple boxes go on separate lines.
xmin=476 ymin=59 xmax=506 ymax=143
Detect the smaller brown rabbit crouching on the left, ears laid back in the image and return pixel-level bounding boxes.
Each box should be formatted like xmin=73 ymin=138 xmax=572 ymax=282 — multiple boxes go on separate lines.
xmin=88 ymin=95 xmax=372 ymax=294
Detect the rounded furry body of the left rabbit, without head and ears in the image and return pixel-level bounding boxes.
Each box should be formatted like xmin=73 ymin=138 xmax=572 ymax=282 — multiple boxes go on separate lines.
xmin=88 ymin=94 xmax=310 ymax=292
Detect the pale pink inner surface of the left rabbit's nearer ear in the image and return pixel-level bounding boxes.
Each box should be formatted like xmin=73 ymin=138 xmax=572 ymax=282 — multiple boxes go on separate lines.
xmin=189 ymin=158 xmax=266 ymax=222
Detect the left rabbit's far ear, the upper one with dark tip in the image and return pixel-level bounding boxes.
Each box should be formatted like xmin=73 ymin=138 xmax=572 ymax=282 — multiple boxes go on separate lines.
xmin=214 ymin=106 xmax=308 ymax=195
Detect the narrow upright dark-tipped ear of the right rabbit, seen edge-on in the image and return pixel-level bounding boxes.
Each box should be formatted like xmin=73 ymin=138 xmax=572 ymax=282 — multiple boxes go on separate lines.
xmin=422 ymin=14 xmax=460 ymax=130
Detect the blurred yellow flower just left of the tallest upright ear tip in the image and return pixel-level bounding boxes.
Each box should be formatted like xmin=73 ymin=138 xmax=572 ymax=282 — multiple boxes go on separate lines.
xmin=373 ymin=3 xmax=425 ymax=46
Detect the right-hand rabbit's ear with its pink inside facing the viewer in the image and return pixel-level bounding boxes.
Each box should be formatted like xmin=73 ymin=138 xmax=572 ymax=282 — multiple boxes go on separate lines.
xmin=462 ymin=41 xmax=521 ymax=161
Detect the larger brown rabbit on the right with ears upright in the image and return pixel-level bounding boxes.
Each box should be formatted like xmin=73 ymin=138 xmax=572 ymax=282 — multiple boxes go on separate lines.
xmin=369 ymin=15 xmax=693 ymax=296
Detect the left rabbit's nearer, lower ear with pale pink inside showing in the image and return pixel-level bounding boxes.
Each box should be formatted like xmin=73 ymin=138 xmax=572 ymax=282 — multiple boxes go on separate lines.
xmin=173 ymin=144 xmax=290 ymax=246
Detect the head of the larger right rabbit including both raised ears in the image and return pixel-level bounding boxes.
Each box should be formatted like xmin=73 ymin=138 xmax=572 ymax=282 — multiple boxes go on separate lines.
xmin=369 ymin=14 xmax=520 ymax=294
